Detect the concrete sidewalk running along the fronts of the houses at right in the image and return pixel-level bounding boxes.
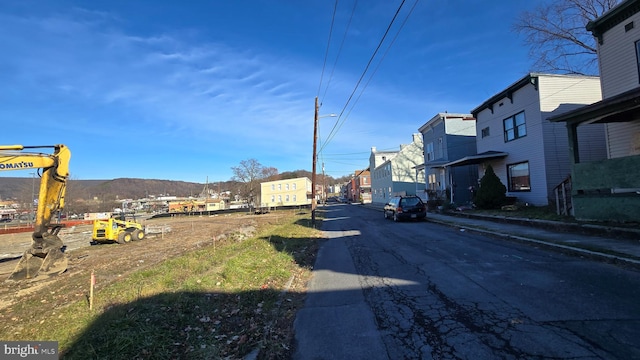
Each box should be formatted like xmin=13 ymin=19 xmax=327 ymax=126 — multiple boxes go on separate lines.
xmin=364 ymin=205 xmax=640 ymax=267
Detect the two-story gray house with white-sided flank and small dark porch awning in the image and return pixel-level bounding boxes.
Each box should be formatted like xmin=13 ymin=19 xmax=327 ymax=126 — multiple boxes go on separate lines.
xmin=464 ymin=73 xmax=605 ymax=206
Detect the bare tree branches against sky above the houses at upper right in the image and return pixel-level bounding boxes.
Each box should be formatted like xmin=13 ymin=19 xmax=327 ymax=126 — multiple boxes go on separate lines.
xmin=513 ymin=0 xmax=619 ymax=75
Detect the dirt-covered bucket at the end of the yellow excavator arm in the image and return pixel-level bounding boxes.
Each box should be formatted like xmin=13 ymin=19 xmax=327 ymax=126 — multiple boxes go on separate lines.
xmin=7 ymin=234 xmax=69 ymax=281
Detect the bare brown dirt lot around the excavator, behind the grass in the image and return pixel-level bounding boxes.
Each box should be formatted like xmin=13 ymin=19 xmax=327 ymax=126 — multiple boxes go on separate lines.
xmin=0 ymin=213 xmax=286 ymax=312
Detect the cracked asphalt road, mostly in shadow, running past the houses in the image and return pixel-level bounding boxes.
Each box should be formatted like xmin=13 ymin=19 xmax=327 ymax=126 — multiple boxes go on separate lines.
xmin=295 ymin=204 xmax=640 ymax=359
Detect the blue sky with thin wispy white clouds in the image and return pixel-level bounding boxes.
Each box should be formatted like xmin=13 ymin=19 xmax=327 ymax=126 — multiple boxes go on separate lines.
xmin=0 ymin=0 xmax=535 ymax=183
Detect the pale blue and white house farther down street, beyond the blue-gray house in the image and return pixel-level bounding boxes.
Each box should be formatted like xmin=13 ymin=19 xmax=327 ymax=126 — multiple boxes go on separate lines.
xmin=369 ymin=134 xmax=424 ymax=204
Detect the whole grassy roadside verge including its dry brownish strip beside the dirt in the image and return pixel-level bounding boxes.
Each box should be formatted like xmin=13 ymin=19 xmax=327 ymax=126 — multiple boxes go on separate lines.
xmin=0 ymin=212 xmax=322 ymax=359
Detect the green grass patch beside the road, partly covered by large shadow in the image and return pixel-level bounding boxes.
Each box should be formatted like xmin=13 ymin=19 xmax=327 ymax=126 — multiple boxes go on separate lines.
xmin=0 ymin=214 xmax=321 ymax=359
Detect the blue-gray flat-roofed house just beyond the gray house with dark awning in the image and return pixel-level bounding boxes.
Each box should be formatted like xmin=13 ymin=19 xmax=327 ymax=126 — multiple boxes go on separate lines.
xmin=417 ymin=112 xmax=478 ymax=205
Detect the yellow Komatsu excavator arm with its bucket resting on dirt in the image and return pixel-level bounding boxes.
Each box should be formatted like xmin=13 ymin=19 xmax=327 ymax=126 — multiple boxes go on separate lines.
xmin=0 ymin=145 xmax=71 ymax=281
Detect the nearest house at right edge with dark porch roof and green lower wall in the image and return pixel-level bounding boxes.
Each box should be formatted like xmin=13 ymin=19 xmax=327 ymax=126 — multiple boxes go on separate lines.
xmin=550 ymin=0 xmax=640 ymax=221
